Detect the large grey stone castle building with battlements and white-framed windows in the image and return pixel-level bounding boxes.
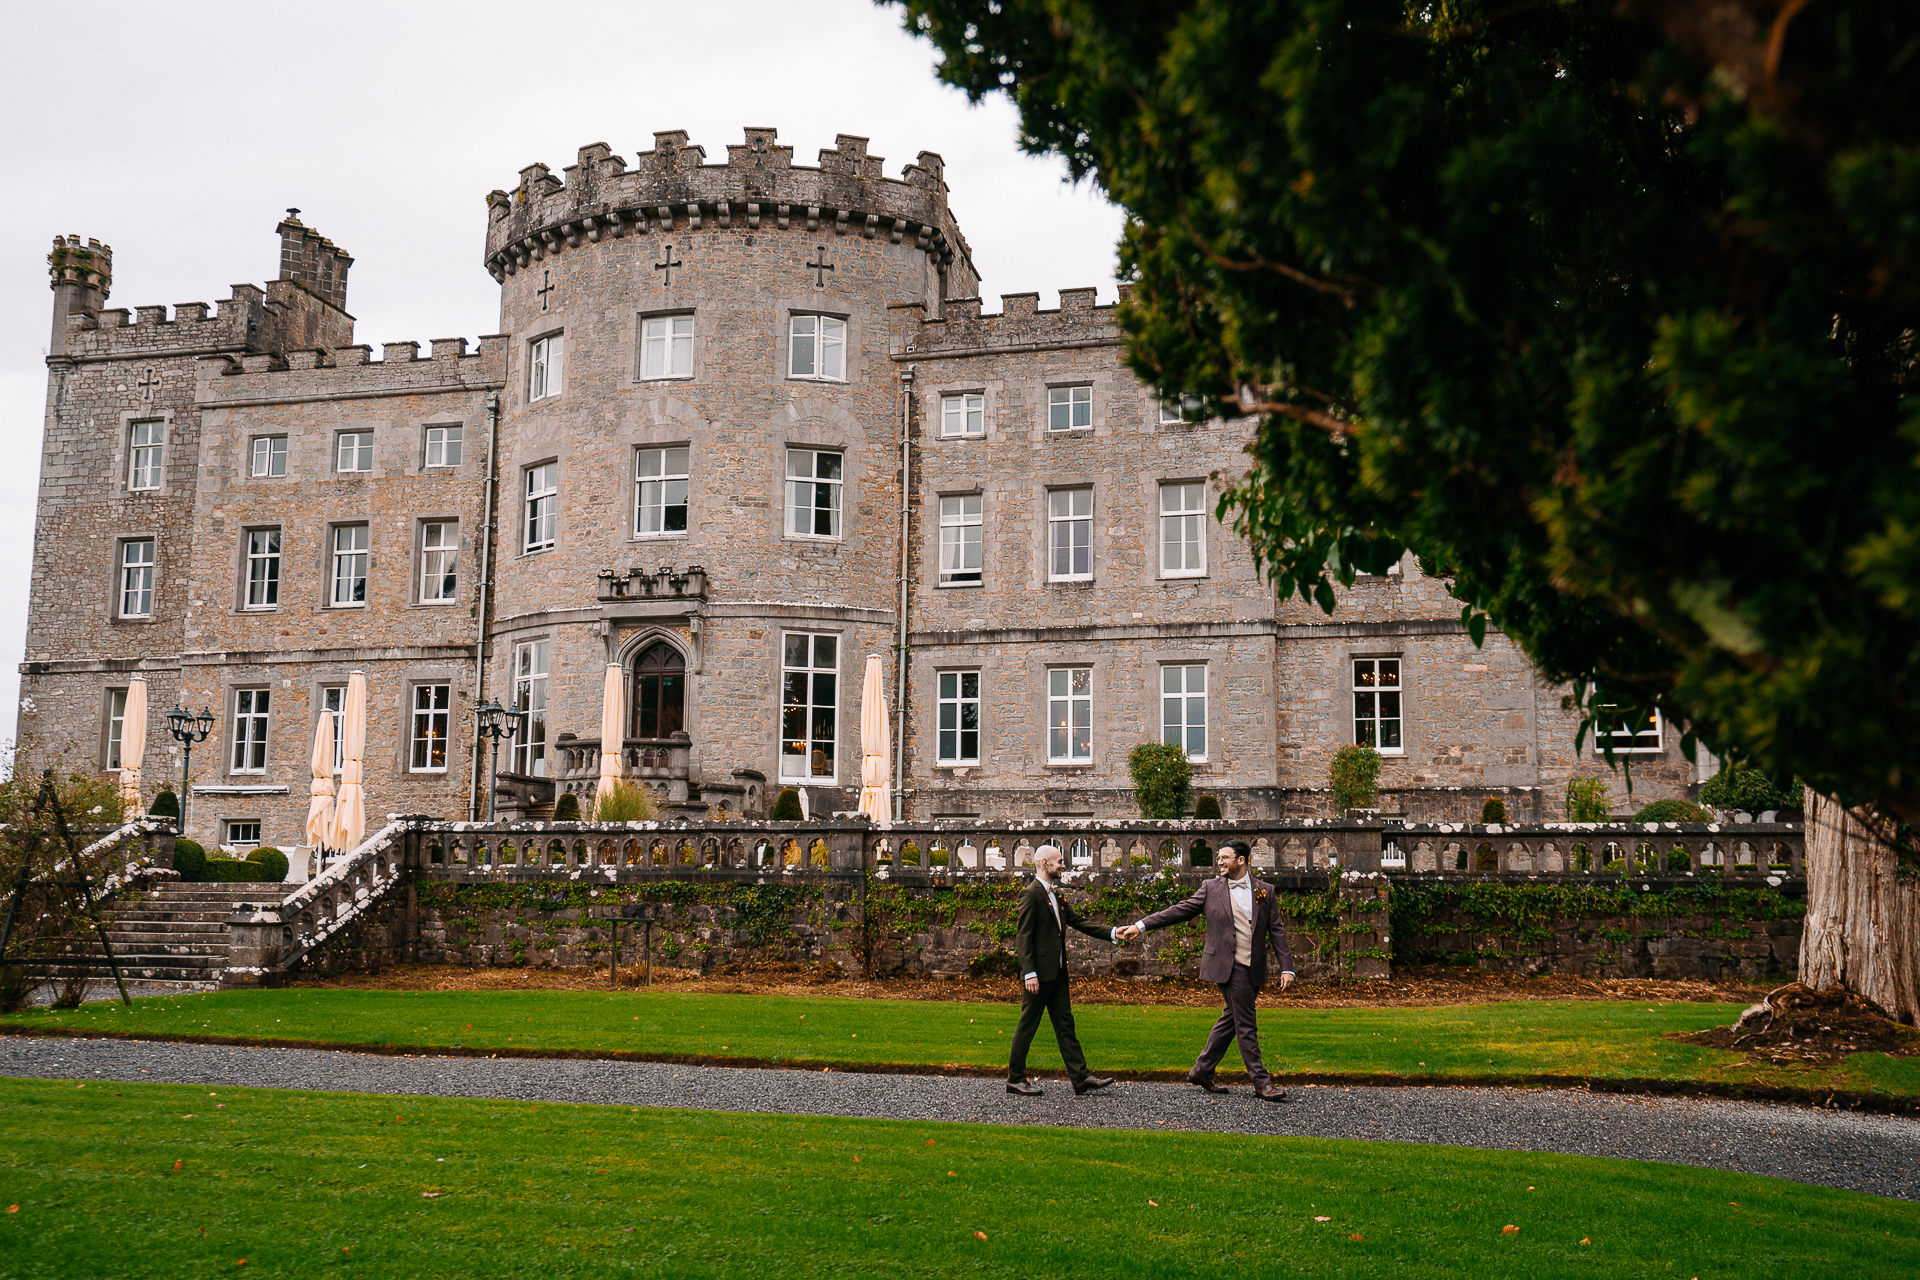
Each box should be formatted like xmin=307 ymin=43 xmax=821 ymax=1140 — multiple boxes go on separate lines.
xmin=19 ymin=129 xmax=1692 ymax=844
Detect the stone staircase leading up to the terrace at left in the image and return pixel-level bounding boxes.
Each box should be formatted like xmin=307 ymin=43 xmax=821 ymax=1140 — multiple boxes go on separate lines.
xmin=88 ymin=881 xmax=300 ymax=988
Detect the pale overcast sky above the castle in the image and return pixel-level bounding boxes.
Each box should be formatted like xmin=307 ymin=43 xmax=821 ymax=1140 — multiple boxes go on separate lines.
xmin=0 ymin=0 xmax=1119 ymax=752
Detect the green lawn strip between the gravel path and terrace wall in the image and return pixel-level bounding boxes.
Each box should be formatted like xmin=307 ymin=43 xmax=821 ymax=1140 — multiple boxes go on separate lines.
xmin=0 ymin=988 xmax=1920 ymax=1096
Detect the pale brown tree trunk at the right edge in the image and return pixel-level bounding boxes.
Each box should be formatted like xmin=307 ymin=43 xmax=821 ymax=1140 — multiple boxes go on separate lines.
xmin=1799 ymin=791 xmax=1920 ymax=1025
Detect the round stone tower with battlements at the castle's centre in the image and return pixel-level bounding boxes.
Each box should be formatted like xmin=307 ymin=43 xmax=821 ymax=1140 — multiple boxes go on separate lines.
xmin=486 ymin=129 xmax=977 ymax=814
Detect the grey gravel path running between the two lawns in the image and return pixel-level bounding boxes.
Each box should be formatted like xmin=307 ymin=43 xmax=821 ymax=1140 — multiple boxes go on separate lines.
xmin=0 ymin=1036 xmax=1920 ymax=1199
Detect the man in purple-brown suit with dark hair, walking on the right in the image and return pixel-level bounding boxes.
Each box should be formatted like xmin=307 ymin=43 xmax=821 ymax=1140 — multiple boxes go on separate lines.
xmin=1117 ymin=841 xmax=1294 ymax=1102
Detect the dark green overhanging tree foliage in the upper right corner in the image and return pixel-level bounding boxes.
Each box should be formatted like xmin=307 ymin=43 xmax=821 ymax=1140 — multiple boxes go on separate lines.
xmin=904 ymin=0 xmax=1920 ymax=819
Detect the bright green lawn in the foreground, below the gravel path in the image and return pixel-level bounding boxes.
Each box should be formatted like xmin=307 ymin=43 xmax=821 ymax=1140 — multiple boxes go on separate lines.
xmin=0 ymin=1080 xmax=1920 ymax=1280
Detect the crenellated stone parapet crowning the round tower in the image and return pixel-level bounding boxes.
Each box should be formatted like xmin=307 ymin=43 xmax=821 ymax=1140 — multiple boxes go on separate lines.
xmin=486 ymin=129 xmax=973 ymax=280
